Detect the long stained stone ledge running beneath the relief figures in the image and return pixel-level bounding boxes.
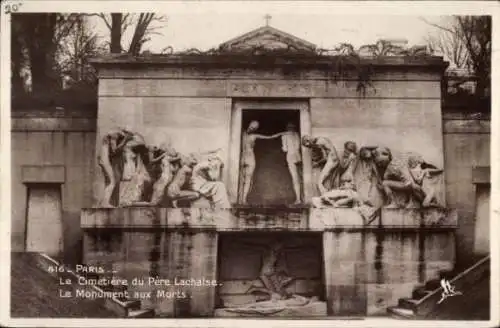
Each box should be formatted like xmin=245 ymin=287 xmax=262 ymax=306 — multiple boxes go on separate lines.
xmin=80 ymin=206 xmax=457 ymax=232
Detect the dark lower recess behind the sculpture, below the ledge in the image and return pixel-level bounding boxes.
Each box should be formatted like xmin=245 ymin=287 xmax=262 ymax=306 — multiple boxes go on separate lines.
xmin=216 ymin=232 xmax=326 ymax=308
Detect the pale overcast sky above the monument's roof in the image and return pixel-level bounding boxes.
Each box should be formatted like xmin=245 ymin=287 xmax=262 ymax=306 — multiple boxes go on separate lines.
xmin=87 ymin=11 xmax=445 ymax=52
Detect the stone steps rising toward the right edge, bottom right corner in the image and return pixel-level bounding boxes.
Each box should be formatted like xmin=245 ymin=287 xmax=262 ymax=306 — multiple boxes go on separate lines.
xmin=387 ymin=256 xmax=490 ymax=320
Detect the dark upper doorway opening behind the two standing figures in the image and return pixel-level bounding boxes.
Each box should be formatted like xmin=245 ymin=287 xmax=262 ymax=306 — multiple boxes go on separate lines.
xmin=240 ymin=109 xmax=300 ymax=206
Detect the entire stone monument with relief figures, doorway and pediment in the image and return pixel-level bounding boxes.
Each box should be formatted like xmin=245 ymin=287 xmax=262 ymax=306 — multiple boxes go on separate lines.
xmin=81 ymin=26 xmax=457 ymax=318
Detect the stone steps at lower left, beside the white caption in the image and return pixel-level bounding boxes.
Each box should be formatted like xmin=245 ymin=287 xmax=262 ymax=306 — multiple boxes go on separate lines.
xmin=34 ymin=253 xmax=155 ymax=318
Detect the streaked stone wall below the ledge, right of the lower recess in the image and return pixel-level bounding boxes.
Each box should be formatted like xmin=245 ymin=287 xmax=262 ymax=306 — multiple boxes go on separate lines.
xmin=323 ymin=231 xmax=455 ymax=317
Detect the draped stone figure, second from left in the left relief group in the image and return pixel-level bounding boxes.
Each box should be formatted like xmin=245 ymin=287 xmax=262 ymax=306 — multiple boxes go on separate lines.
xmin=119 ymin=133 xmax=151 ymax=206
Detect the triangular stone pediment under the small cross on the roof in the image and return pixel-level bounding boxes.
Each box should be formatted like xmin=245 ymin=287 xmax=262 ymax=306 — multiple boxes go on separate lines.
xmin=220 ymin=26 xmax=316 ymax=51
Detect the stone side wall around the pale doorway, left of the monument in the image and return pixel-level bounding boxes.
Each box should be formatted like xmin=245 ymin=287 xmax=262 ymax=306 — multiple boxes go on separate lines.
xmin=11 ymin=110 xmax=96 ymax=263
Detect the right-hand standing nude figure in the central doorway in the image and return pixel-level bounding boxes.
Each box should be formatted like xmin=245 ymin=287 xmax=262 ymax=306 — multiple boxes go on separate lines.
xmin=281 ymin=123 xmax=302 ymax=204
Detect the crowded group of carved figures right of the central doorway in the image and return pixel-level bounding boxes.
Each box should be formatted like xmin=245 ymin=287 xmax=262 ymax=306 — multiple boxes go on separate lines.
xmin=302 ymin=136 xmax=443 ymax=214
